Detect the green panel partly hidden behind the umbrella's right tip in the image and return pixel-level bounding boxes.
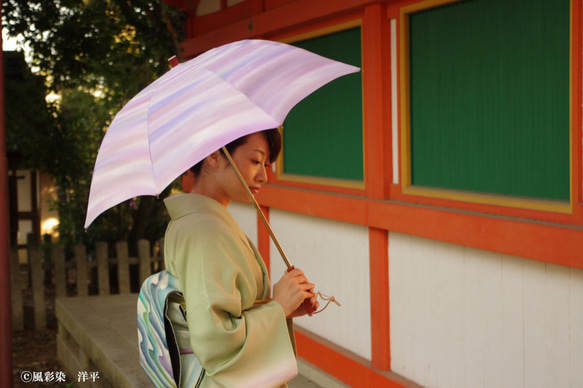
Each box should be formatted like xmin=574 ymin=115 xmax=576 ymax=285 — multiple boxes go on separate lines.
xmin=283 ymin=28 xmax=363 ymax=180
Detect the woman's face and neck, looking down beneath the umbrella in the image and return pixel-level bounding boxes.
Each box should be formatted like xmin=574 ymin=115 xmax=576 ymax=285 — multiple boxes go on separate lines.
xmin=215 ymin=133 xmax=269 ymax=206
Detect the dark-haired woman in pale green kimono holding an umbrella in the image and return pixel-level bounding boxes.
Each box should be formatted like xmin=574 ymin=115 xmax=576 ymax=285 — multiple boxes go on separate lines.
xmin=165 ymin=129 xmax=318 ymax=388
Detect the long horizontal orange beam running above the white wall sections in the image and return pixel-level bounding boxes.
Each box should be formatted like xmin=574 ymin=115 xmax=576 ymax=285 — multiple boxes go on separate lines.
xmin=259 ymin=185 xmax=583 ymax=269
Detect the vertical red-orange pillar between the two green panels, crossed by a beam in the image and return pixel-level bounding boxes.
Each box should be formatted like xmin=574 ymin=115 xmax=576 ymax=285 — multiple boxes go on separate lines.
xmin=362 ymin=3 xmax=392 ymax=371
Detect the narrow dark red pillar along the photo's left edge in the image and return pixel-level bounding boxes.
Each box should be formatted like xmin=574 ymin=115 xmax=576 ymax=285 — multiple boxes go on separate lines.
xmin=0 ymin=0 xmax=12 ymax=387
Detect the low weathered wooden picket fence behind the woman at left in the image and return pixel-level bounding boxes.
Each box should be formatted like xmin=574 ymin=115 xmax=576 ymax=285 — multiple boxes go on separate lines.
xmin=10 ymin=239 xmax=164 ymax=330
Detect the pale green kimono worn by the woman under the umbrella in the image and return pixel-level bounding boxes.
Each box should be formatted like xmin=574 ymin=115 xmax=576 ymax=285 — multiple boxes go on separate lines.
xmin=164 ymin=194 xmax=297 ymax=388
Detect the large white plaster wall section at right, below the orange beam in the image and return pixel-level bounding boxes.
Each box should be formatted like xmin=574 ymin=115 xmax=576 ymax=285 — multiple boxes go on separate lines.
xmin=389 ymin=232 xmax=583 ymax=388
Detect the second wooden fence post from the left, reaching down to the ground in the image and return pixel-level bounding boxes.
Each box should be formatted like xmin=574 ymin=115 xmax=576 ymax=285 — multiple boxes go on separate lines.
xmin=28 ymin=234 xmax=47 ymax=330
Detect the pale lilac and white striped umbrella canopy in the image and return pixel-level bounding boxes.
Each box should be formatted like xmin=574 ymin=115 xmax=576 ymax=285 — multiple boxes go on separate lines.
xmin=85 ymin=40 xmax=360 ymax=228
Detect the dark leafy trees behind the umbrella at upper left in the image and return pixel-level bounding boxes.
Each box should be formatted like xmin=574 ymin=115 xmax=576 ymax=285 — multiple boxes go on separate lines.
xmin=2 ymin=0 xmax=184 ymax=253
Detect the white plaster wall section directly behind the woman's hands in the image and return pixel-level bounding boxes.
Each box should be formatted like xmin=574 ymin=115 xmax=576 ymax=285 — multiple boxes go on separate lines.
xmin=270 ymin=209 xmax=371 ymax=360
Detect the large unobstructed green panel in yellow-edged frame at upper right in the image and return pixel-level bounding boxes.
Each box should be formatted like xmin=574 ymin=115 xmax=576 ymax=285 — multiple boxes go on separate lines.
xmin=409 ymin=0 xmax=570 ymax=200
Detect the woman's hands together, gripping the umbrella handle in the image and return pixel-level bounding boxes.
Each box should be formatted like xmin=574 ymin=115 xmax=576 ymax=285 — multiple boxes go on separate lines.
xmin=273 ymin=268 xmax=319 ymax=318
